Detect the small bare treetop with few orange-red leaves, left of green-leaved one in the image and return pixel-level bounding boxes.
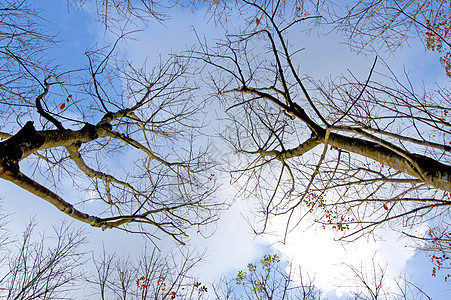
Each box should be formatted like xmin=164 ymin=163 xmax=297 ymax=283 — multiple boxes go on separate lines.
xmin=86 ymin=245 xmax=207 ymax=299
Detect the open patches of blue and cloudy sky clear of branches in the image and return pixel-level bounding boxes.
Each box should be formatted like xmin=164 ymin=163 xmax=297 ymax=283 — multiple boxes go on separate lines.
xmin=0 ymin=0 xmax=449 ymax=299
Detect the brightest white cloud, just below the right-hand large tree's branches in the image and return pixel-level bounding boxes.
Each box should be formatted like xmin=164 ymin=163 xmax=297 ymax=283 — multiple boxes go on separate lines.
xmin=269 ymin=212 xmax=414 ymax=295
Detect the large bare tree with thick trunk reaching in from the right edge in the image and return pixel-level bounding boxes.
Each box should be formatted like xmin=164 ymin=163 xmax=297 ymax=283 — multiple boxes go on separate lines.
xmin=192 ymin=1 xmax=451 ymax=264
